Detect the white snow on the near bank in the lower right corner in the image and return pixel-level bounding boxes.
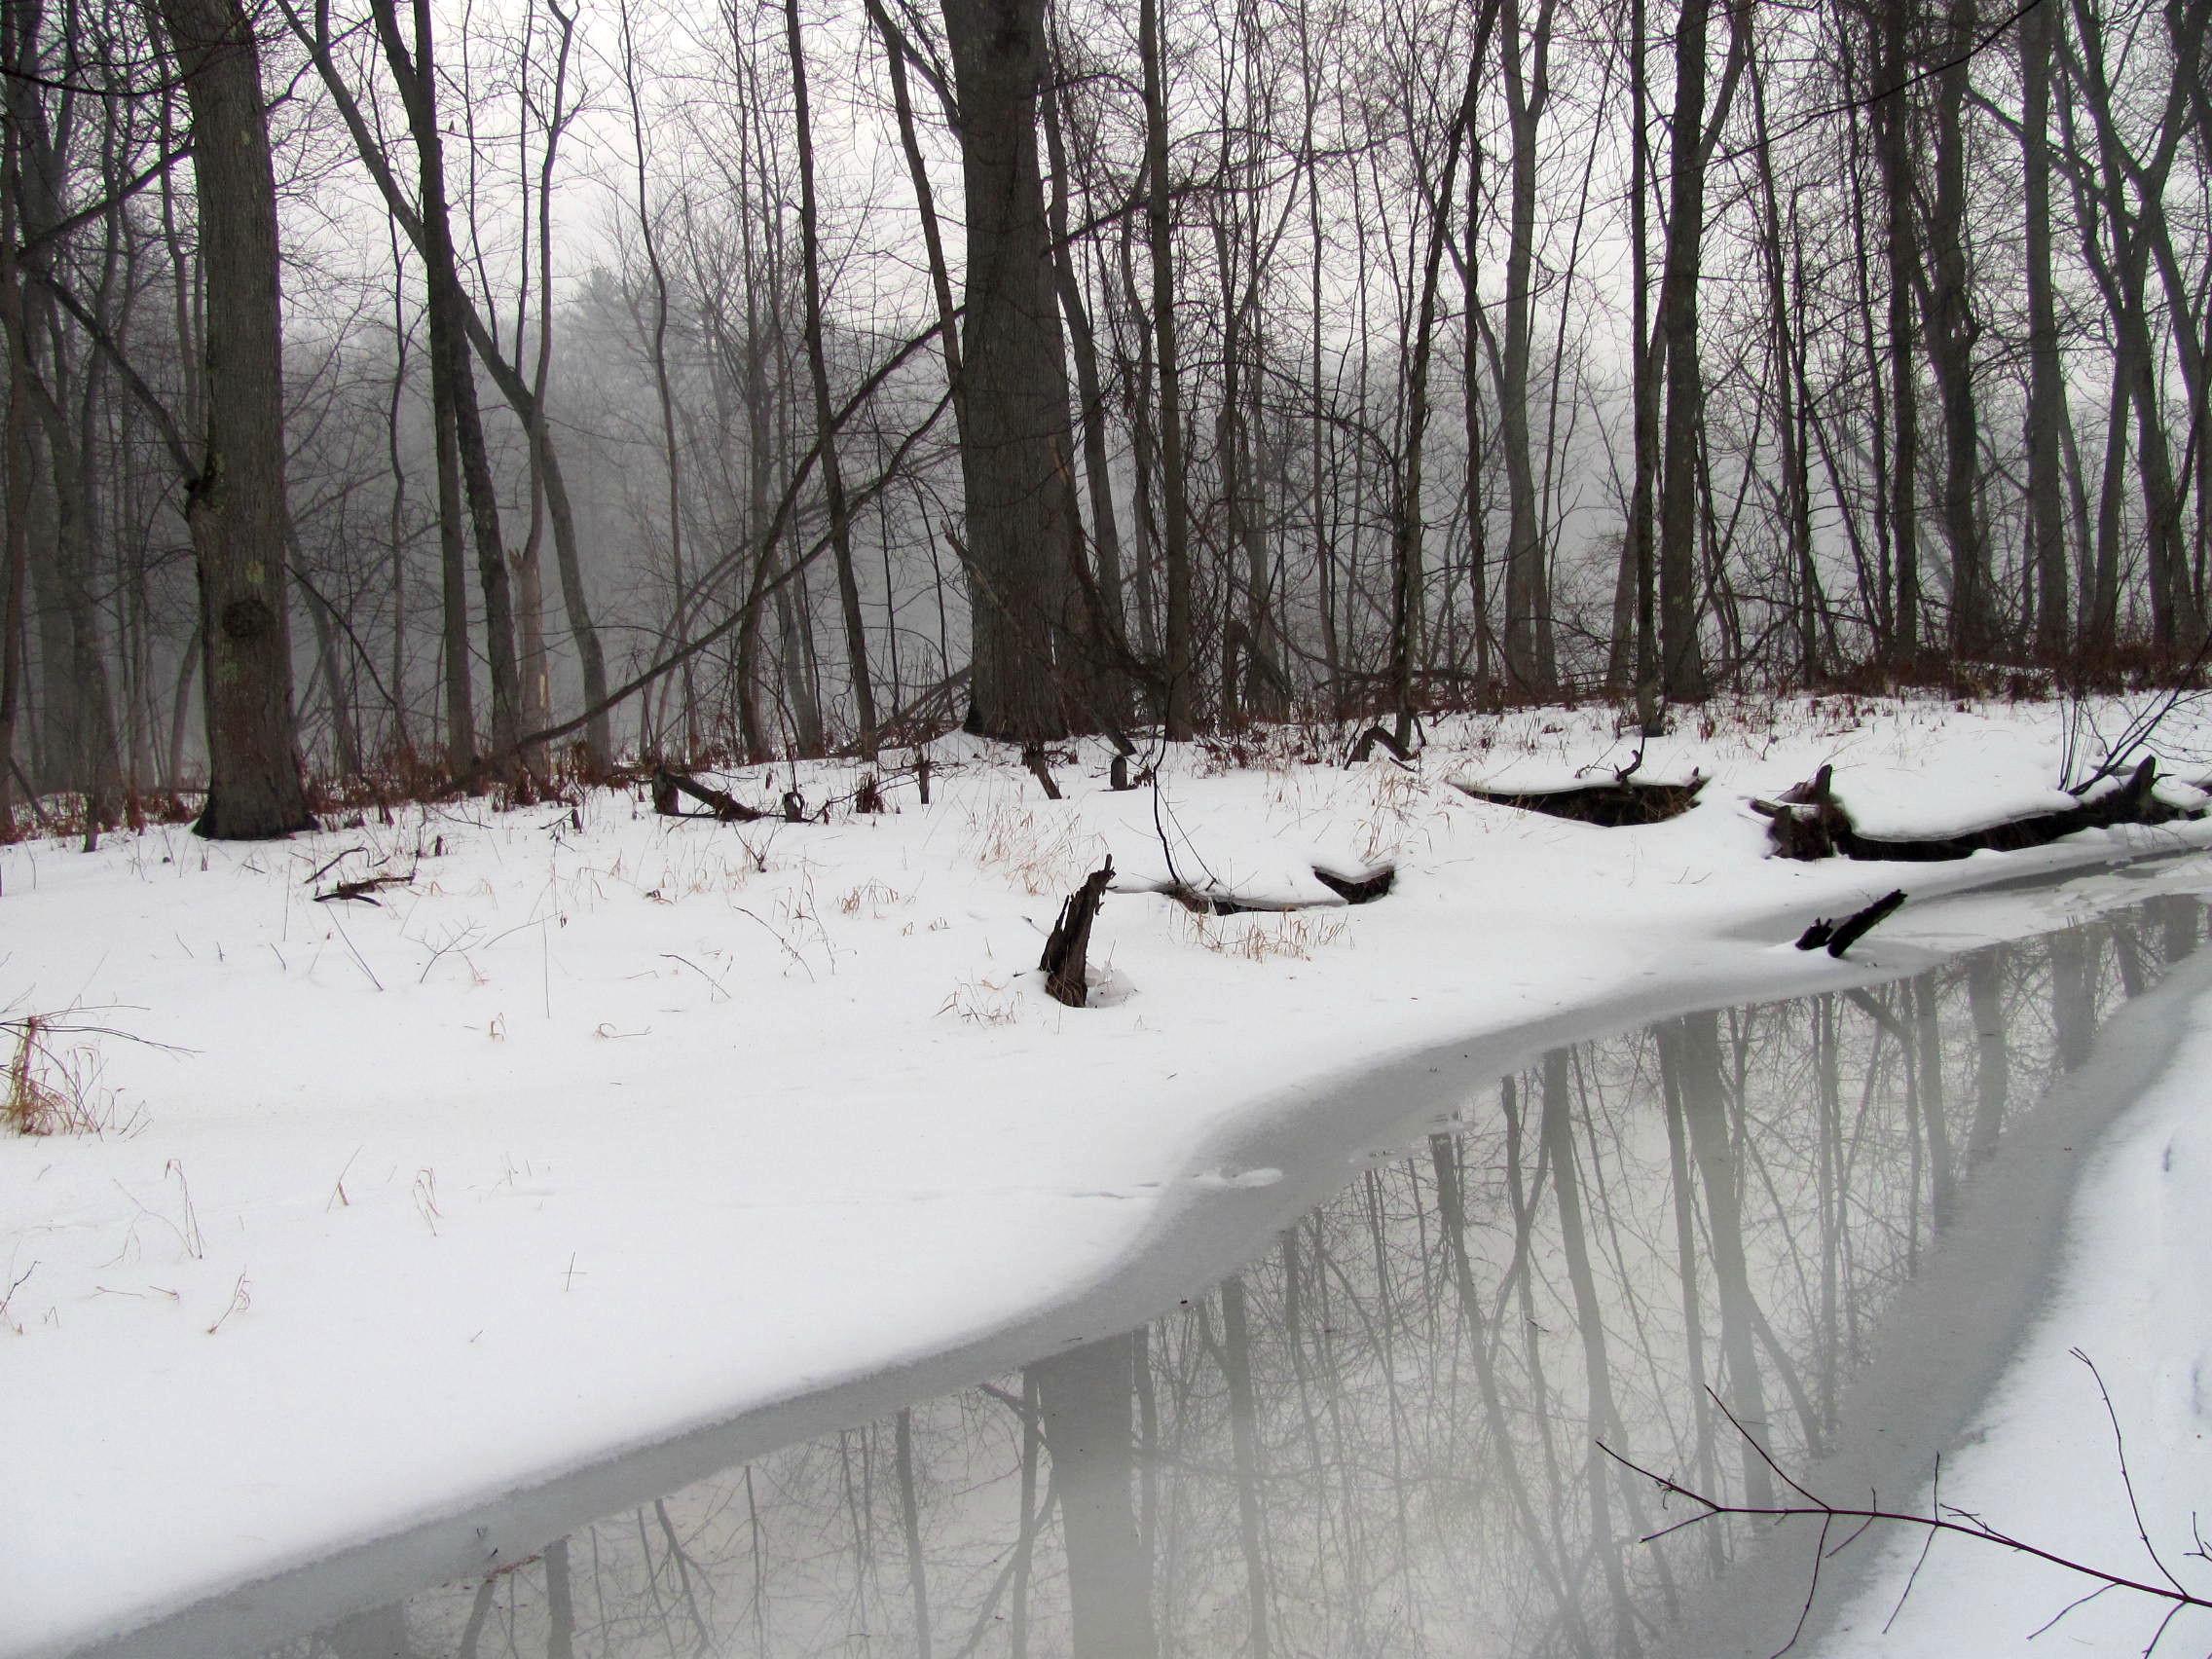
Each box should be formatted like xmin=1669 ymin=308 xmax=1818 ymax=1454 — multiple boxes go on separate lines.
xmin=1816 ymin=965 xmax=2212 ymax=1659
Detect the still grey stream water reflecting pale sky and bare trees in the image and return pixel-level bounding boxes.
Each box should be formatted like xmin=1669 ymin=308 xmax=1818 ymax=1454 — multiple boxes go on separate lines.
xmin=299 ymin=898 xmax=2198 ymax=1659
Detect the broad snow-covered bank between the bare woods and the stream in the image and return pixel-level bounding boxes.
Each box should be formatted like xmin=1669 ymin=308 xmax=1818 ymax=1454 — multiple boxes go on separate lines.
xmin=13 ymin=699 xmax=2212 ymax=1654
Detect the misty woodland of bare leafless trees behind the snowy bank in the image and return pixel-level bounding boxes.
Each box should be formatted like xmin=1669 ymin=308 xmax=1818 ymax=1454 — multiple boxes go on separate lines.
xmin=0 ymin=0 xmax=2212 ymax=838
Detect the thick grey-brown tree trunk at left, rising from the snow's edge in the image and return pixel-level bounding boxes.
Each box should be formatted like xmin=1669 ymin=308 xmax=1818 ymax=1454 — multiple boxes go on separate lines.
xmin=162 ymin=0 xmax=314 ymax=840
